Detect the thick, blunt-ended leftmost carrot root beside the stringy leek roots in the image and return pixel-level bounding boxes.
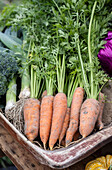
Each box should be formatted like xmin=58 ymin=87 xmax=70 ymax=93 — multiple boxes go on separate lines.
xmin=24 ymin=98 xmax=40 ymax=141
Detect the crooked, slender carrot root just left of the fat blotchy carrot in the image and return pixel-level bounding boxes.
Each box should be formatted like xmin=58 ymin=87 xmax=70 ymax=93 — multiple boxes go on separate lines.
xmin=66 ymin=87 xmax=84 ymax=146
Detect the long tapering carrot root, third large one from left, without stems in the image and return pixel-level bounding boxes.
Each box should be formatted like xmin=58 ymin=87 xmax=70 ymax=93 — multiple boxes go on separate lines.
xmin=49 ymin=92 xmax=67 ymax=150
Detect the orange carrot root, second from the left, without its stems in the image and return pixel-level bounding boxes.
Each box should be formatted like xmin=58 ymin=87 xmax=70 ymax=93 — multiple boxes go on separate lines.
xmin=40 ymin=95 xmax=54 ymax=148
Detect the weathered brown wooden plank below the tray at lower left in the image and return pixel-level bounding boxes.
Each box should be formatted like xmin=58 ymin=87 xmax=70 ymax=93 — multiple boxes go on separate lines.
xmin=0 ymin=125 xmax=51 ymax=170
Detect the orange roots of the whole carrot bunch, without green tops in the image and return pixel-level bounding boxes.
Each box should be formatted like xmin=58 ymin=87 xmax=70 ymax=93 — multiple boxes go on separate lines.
xmin=24 ymin=74 xmax=104 ymax=150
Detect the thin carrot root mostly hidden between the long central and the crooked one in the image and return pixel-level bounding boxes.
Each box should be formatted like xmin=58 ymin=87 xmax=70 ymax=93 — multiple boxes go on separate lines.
xmin=59 ymin=108 xmax=70 ymax=145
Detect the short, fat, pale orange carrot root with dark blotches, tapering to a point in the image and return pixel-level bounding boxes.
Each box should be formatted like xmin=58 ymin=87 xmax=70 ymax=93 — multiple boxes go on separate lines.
xmin=79 ymin=99 xmax=100 ymax=138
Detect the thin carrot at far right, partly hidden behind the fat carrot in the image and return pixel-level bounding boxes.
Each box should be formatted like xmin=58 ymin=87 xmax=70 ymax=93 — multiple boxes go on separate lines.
xmin=96 ymin=92 xmax=105 ymax=130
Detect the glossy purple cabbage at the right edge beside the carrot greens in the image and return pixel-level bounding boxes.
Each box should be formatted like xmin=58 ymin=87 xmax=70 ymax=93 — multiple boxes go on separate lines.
xmin=98 ymin=31 xmax=112 ymax=77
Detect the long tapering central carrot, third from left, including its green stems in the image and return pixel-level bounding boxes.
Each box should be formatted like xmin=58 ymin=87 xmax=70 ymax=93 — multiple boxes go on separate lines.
xmin=49 ymin=53 xmax=67 ymax=150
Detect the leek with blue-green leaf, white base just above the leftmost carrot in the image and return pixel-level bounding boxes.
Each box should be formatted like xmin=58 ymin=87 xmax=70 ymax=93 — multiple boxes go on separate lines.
xmin=0 ymin=28 xmax=30 ymax=98
